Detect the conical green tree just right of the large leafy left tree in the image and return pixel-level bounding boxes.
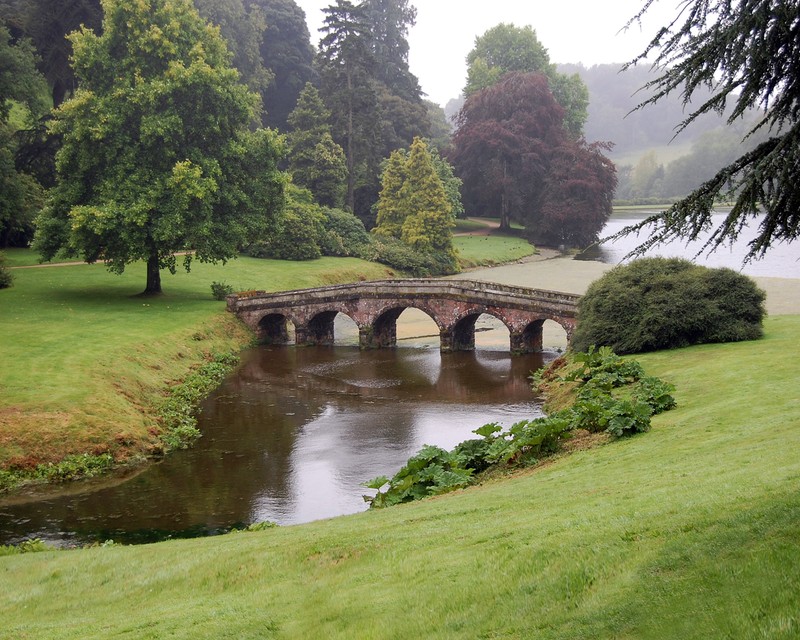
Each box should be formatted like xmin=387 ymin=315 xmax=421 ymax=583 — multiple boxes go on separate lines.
xmin=288 ymin=83 xmax=347 ymax=208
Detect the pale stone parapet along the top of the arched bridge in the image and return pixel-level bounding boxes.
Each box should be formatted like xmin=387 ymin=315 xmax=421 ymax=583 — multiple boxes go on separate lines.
xmin=227 ymin=278 xmax=580 ymax=312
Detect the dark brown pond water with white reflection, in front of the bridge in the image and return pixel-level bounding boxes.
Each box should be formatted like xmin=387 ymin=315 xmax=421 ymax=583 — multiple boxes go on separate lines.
xmin=0 ymin=342 xmax=554 ymax=544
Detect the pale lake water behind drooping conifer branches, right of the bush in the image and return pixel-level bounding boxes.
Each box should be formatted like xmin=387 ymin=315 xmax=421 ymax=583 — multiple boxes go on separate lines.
xmin=576 ymin=209 xmax=800 ymax=278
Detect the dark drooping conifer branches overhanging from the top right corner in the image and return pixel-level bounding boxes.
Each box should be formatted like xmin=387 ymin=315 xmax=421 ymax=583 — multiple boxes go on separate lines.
xmin=622 ymin=0 xmax=800 ymax=261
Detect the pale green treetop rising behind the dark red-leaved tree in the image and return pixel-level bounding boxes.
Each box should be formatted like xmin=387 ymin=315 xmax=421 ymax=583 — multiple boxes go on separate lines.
xmin=464 ymin=24 xmax=589 ymax=138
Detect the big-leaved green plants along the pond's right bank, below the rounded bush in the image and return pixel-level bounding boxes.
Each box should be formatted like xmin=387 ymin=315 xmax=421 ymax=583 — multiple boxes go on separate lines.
xmin=364 ymin=347 xmax=675 ymax=508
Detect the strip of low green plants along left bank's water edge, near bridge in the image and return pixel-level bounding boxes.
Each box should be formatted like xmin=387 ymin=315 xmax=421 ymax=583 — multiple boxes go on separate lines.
xmin=159 ymin=354 xmax=239 ymax=452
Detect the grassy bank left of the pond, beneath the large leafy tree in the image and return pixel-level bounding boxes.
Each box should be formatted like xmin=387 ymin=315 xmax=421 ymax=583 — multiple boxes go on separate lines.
xmin=0 ymin=251 xmax=396 ymax=467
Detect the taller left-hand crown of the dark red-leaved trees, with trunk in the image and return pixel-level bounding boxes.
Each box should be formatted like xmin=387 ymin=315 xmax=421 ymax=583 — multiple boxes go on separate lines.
xmin=451 ymin=73 xmax=565 ymax=229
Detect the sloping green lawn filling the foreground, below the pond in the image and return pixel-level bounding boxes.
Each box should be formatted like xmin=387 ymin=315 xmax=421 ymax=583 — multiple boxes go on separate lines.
xmin=0 ymin=316 xmax=800 ymax=640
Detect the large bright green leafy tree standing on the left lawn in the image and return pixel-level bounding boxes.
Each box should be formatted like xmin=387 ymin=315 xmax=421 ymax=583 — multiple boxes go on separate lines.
xmin=36 ymin=0 xmax=284 ymax=294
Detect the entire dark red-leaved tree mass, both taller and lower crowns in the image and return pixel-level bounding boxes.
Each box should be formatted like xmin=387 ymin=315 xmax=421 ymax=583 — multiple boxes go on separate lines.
xmin=450 ymin=72 xmax=616 ymax=246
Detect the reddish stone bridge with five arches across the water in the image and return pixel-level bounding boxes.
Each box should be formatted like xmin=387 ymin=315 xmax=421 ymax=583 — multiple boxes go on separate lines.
xmin=227 ymin=279 xmax=580 ymax=353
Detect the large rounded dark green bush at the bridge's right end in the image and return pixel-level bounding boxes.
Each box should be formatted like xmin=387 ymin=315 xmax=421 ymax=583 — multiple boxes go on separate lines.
xmin=572 ymin=258 xmax=766 ymax=353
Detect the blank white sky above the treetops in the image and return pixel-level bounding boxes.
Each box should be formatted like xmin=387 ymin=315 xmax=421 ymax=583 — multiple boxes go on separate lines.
xmin=296 ymin=0 xmax=682 ymax=106
